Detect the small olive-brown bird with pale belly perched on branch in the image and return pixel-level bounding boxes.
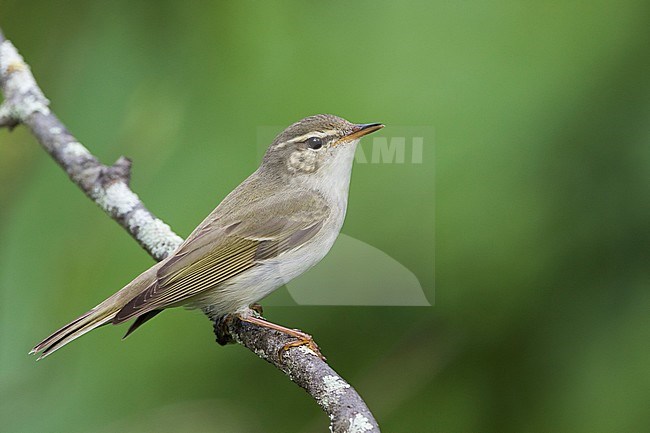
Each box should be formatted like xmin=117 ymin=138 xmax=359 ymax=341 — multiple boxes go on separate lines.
xmin=30 ymin=114 xmax=384 ymax=359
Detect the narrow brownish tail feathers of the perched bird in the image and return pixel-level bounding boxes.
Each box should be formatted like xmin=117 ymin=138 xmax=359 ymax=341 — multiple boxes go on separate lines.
xmin=29 ymin=304 xmax=117 ymax=359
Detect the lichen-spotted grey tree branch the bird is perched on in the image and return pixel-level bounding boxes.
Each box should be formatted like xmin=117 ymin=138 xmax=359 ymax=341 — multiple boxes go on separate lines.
xmin=0 ymin=29 xmax=379 ymax=433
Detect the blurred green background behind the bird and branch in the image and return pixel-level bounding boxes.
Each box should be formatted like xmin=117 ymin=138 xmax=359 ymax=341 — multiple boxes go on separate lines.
xmin=0 ymin=0 xmax=650 ymax=433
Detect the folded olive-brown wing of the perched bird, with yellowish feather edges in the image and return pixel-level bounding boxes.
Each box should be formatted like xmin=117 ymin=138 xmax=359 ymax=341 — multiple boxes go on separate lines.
xmin=113 ymin=193 xmax=329 ymax=324
